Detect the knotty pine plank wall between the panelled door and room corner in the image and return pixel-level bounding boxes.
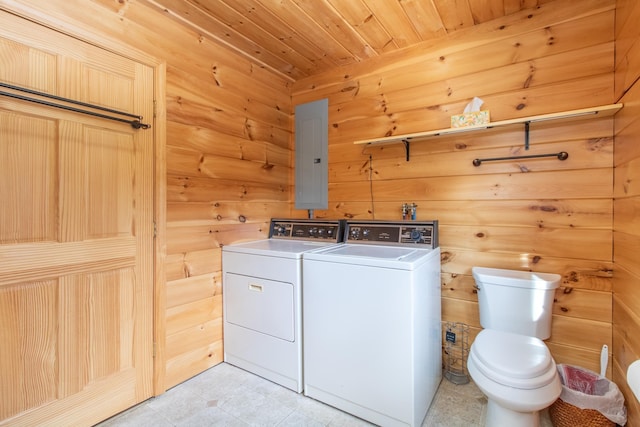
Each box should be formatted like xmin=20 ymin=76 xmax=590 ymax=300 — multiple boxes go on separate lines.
xmin=1 ymin=0 xmax=293 ymax=393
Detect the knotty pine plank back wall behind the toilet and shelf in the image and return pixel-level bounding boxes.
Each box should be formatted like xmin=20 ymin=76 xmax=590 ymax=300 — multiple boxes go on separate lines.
xmin=293 ymin=0 xmax=615 ymax=382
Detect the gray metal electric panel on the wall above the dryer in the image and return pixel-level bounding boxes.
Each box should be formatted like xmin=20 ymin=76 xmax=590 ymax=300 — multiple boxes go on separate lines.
xmin=295 ymin=99 xmax=329 ymax=209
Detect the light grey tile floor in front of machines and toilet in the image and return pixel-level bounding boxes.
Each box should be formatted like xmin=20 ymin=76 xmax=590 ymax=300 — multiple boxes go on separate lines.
xmin=98 ymin=363 xmax=551 ymax=427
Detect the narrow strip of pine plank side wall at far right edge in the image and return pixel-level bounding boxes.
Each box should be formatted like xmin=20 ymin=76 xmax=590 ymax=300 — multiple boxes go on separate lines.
xmin=613 ymin=0 xmax=640 ymax=426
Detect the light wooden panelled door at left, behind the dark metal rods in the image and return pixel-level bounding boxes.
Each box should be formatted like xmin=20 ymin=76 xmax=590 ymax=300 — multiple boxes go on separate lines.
xmin=0 ymin=12 xmax=153 ymax=426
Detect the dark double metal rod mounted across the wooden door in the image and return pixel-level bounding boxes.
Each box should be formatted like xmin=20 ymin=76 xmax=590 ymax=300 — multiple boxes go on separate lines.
xmin=0 ymin=82 xmax=151 ymax=129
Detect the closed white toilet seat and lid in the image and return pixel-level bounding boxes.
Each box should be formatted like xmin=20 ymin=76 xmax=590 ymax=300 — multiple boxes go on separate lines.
xmin=470 ymin=329 xmax=557 ymax=390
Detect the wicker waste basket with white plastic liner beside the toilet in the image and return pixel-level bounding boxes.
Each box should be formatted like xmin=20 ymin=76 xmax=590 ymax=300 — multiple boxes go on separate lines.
xmin=549 ymin=365 xmax=627 ymax=427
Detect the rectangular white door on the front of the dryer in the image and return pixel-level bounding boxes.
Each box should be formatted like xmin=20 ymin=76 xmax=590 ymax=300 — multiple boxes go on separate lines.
xmin=224 ymin=273 xmax=295 ymax=342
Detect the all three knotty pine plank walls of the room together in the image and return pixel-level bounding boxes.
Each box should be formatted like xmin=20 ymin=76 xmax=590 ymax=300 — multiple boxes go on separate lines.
xmin=6 ymin=0 xmax=640 ymax=423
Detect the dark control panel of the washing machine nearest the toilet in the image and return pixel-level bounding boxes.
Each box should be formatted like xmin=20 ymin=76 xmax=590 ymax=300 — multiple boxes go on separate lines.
xmin=345 ymin=220 xmax=438 ymax=249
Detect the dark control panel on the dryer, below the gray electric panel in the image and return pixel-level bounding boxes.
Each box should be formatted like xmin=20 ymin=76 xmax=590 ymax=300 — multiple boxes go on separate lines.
xmin=269 ymin=219 xmax=344 ymax=243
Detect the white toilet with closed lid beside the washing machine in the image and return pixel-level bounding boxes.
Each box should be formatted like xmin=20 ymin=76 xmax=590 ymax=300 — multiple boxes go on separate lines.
xmin=467 ymin=267 xmax=562 ymax=427
